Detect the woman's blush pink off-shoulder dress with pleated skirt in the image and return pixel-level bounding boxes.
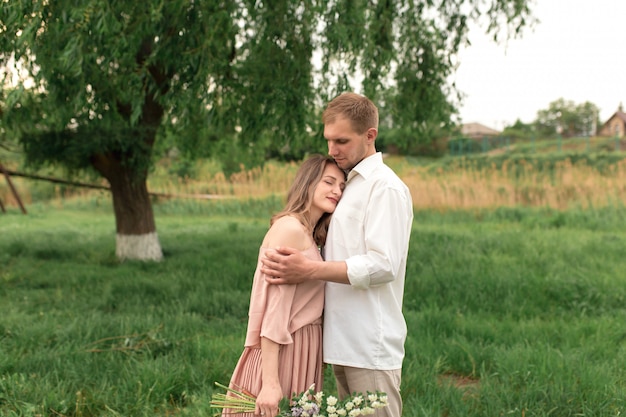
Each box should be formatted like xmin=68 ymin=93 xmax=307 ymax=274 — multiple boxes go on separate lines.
xmin=224 ymin=246 xmax=324 ymax=415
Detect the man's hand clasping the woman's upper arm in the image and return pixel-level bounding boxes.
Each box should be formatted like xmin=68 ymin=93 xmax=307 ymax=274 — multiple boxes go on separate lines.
xmin=261 ymin=247 xmax=314 ymax=284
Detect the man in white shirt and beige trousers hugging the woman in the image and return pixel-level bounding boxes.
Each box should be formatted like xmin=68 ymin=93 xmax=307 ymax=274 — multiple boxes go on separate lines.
xmin=261 ymin=93 xmax=413 ymax=417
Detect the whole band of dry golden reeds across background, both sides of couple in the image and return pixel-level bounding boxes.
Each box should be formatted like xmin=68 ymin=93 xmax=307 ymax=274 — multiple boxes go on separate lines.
xmin=0 ymin=153 xmax=626 ymax=210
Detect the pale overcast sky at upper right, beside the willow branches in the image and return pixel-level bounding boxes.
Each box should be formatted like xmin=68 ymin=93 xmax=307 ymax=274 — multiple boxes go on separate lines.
xmin=453 ymin=0 xmax=626 ymax=130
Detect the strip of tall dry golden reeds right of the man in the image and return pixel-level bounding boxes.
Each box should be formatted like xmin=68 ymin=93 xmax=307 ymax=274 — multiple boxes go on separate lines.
xmin=400 ymin=160 xmax=626 ymax=210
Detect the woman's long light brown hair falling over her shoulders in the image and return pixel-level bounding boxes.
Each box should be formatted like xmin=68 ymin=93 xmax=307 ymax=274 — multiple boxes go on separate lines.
xmin=270 ymin=154 xmax=344 ymax=247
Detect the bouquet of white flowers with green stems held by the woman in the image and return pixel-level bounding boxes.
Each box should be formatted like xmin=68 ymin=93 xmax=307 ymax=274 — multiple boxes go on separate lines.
xmin=211 ymin=382 xmax=389 ymax=417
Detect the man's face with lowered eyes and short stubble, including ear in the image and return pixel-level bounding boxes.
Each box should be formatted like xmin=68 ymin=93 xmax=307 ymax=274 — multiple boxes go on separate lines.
xmin=324 ymin=117 xmax=377 ymax=170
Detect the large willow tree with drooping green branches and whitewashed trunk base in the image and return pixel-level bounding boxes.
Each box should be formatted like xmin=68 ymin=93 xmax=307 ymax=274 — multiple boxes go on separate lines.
xmin=0 ymin=0 xmax=530 ymax=259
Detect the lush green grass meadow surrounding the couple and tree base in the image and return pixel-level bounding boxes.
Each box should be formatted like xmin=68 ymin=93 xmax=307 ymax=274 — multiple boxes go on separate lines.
xmin=0 ymin=203 xmax=626 ymax=417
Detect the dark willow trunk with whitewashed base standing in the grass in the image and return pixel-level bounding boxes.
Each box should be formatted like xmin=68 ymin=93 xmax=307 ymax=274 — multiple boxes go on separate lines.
xmin=94 ymin=155 xmax=163 ymax=261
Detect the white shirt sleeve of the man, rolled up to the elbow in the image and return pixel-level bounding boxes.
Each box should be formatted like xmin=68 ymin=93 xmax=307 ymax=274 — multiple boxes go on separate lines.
xmin=346 ymin=185 xmax=413 ymax=289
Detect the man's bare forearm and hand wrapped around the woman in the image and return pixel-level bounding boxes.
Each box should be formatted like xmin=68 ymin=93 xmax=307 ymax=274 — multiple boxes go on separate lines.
xmin=261 ymin=247 xmax=350 ymax=284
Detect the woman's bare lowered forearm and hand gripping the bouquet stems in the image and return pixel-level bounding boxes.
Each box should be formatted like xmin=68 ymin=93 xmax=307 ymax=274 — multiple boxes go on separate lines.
xmin=255 ymin=337 xmax=283 ymax=417
